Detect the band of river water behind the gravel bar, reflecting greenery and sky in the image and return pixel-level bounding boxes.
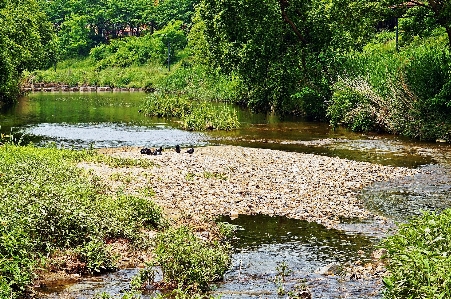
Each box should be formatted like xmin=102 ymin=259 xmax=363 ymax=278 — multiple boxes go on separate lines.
xmin=0 ymin=92 xmax=448 ymax=167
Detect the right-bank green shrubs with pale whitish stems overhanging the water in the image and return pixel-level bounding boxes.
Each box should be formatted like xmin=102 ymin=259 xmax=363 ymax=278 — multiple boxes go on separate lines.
xmin=328 ymin=33 xmax=451 ymax=140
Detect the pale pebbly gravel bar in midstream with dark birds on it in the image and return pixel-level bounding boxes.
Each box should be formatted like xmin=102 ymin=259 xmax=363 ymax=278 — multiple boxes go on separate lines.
xmin=80 ymin=146 xmax=421 ymax=227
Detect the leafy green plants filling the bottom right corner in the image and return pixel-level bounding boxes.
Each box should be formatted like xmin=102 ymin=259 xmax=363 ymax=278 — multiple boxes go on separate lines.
xmin=383 ymin=209 xmax=451 ymax=299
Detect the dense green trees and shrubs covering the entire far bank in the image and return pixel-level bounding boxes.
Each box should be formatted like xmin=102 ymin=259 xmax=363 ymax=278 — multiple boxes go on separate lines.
xmin=0 ymin=0 xmax=451 ymax=141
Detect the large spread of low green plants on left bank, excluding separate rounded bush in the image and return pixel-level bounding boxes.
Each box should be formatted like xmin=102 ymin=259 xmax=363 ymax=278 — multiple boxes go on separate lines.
xmin=0 ymin=143 xmax=162 ymax=298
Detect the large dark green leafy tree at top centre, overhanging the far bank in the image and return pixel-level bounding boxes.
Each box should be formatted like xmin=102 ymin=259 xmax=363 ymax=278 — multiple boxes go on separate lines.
xmin=190 ymin=0 xmax=379 ymax=119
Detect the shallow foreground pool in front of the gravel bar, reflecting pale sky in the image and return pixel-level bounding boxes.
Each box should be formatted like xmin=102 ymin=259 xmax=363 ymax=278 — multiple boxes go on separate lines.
xmin=214 ymin=215 xmax=380 ymax=298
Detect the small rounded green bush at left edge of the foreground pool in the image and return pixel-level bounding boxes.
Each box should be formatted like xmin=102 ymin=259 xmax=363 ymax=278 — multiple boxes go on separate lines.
xmin=155 ymin=226 xmax=230 ymax=290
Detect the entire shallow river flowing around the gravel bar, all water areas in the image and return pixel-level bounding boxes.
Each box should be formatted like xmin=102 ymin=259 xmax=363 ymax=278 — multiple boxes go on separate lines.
xmin=0 ymin=92 xmax=451 ymax=298
